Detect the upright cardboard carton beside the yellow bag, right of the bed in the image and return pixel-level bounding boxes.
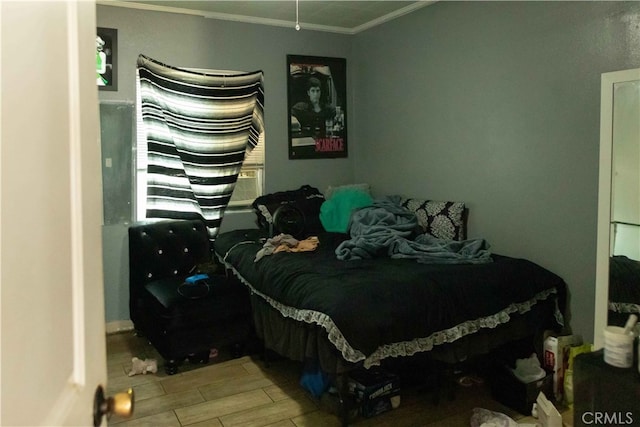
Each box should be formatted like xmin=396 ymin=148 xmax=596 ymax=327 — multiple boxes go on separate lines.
xmin=542 ymin=335 xmax=582 ymax=402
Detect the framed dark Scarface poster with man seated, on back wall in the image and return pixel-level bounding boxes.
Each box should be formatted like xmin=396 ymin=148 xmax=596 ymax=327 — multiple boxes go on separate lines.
xmin=287 ymin=55 xmax=347 ymax=159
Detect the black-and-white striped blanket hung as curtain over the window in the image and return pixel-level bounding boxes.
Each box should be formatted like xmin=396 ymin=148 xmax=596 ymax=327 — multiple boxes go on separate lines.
xmin=136 ymin=55 xmax=264 ymax=242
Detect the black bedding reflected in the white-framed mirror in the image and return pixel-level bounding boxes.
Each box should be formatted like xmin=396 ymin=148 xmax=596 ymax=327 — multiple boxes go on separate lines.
xmin=608 ymin=255 xmax=640 ymax=326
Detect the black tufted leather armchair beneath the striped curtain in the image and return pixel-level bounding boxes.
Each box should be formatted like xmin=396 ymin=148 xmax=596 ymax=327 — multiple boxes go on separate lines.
xmin=129 ymin=220 xmax=252 ymax=375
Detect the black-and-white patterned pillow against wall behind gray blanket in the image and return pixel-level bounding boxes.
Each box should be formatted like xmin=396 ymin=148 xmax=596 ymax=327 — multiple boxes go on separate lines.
xmin=401 ymin=199 xmax=466 ymax=240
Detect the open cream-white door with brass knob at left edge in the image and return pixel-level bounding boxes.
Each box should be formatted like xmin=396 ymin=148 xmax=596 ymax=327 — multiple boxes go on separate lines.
xmin=0 ymin=1 xmax=106 ymax=426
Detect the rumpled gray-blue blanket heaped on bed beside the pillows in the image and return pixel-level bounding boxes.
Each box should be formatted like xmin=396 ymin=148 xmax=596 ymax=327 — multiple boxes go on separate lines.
xmin=336 ymin=196 xmax=492 ymax=264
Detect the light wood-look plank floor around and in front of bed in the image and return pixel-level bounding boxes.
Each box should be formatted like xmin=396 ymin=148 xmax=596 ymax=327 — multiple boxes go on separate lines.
xmin=107 ymin=332 xmax=556 ymax=427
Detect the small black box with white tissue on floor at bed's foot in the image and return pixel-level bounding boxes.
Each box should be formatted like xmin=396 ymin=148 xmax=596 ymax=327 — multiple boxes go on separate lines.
xmin=489 ymin=366 xmax=553 ymax=415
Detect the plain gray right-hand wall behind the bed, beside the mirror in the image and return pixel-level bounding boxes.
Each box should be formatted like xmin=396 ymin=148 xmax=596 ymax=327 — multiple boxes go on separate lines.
xmin=351 ymin=2 xmax=640 ymax=339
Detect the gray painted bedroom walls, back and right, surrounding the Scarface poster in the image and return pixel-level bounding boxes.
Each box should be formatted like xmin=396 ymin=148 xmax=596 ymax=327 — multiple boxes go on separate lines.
xmin=97 ymin=2 xmax=640 ymax=339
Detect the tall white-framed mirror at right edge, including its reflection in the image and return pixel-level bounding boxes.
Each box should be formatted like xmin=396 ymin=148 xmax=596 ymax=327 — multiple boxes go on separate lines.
xmin=594 ymin=68 xmax=640 ymax=348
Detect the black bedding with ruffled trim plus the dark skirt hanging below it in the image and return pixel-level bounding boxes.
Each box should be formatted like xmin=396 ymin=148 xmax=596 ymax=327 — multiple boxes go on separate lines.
xmin=214 ymin=229 xmax=566 ymax=375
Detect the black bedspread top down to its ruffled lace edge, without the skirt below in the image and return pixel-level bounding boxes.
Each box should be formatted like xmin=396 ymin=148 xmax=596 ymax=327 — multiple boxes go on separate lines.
xmin=214 ymin=230 xmax=565 ymax=365
